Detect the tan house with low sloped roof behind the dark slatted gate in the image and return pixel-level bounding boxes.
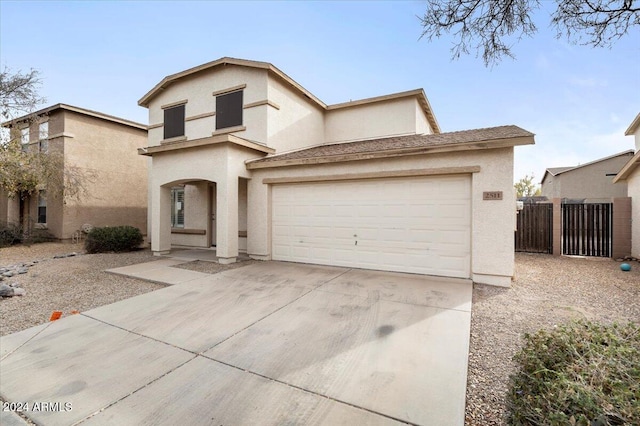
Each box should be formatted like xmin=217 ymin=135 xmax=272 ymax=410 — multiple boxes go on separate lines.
xmin=542 ymin=150 xmax=633 ymax=203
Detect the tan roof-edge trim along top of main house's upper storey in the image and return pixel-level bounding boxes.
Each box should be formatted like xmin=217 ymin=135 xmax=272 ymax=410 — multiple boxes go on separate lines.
xmin=138 ymin=57 xmax=440 ymax=133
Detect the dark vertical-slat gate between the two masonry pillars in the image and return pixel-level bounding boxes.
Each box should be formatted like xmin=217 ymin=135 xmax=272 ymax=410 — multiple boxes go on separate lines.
xmin=562 ymin=203 xmax=613 ymax=257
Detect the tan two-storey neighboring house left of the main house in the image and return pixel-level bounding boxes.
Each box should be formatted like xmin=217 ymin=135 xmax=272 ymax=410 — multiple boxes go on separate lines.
xmin=0 ymin=104 xmax=147 ymax=239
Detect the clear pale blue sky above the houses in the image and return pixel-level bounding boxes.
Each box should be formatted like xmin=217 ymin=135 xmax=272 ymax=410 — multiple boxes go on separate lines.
xmin=0 ymin=0 xmax=640 ymax=180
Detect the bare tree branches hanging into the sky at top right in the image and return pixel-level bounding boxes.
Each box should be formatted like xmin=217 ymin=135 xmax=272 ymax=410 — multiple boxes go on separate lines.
xmin=419 ymin=0 xmax=640 ymax=66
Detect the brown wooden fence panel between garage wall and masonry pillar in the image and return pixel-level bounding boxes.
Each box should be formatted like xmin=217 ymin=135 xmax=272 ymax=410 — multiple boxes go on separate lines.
xmin=516 ymin=204 xmax=553 ymax=254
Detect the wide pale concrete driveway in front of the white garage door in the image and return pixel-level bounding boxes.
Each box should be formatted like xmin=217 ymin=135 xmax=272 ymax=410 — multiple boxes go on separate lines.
xmin=0 ymin=260 xmax=472 ymax=425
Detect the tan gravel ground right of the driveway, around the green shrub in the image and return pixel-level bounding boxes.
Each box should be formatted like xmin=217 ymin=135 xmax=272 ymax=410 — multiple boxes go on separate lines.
xmin=466 ymin=253 xmax=640 ymax=426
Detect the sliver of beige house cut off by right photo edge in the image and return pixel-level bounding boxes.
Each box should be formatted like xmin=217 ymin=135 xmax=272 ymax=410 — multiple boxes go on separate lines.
xmin=613 ymin=113 xmax=640 ymax=258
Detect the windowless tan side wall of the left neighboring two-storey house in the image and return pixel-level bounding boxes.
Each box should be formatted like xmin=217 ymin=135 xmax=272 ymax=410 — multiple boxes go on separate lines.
xmin=60 ymin=110 xmax=147 ymax=238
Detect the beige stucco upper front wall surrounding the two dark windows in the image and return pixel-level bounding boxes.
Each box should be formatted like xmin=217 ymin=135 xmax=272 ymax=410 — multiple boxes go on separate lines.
xmin=149 ymin=65 xmax=270 ymax=146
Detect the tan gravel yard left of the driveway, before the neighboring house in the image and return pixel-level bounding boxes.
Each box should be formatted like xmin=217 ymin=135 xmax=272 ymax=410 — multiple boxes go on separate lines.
xmin=0 ymin=243 xmax=163 ymax=336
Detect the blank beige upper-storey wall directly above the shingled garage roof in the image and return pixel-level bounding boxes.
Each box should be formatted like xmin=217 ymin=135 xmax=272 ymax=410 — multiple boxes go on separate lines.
xmin=324 ymin=97 xmax=424 ymax=143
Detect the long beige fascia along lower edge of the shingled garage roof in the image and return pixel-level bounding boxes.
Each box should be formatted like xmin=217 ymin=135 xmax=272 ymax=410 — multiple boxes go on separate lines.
xmin=245 ymin=136 xmax=535 ymax=169
